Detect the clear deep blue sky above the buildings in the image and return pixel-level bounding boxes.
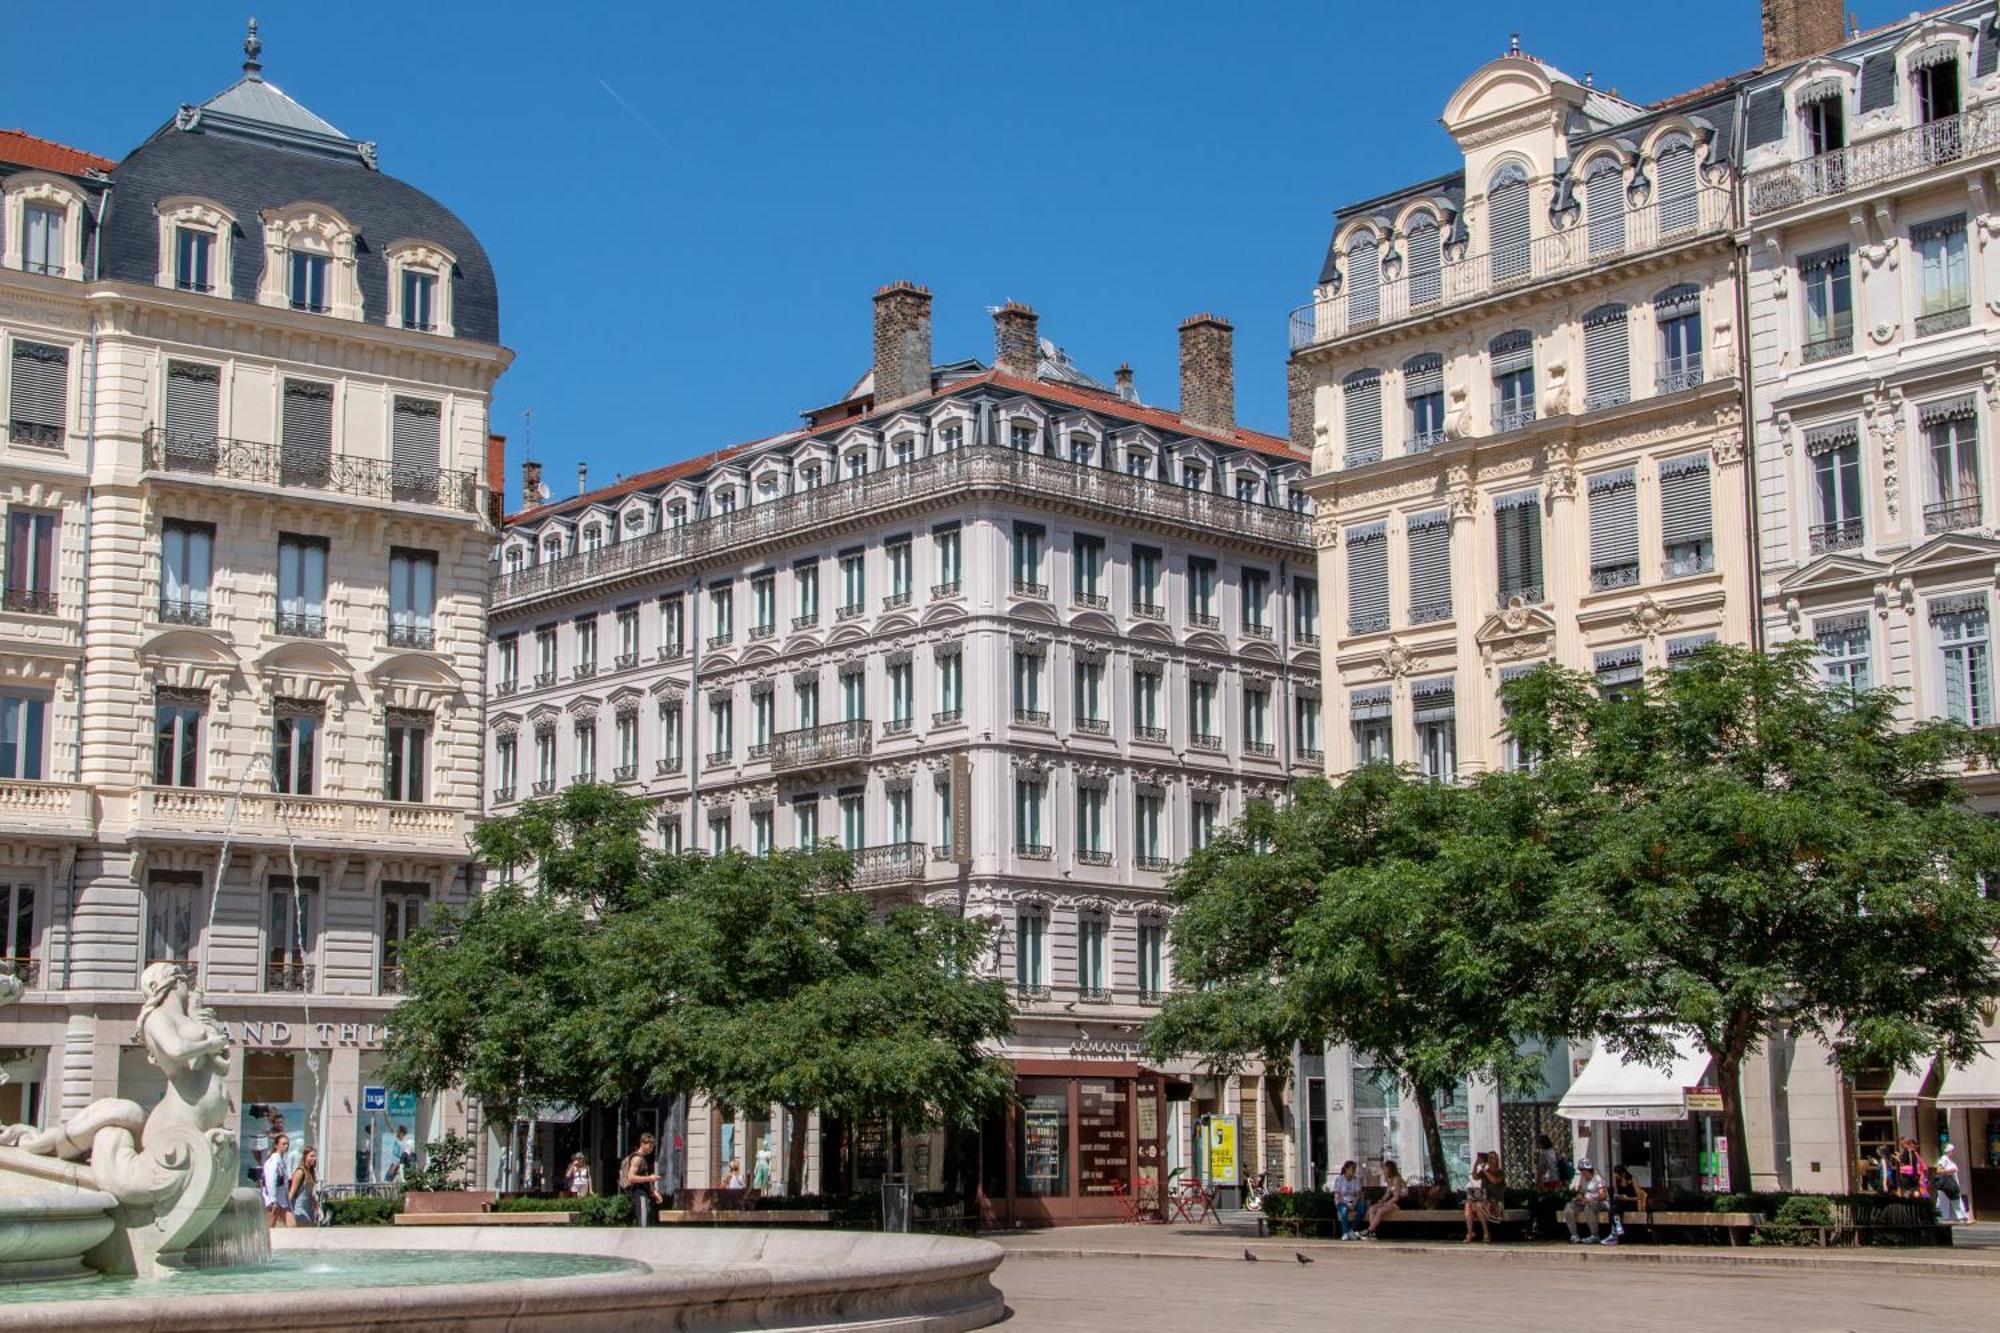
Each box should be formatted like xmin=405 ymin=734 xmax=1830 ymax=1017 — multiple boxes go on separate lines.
xmin=31 ymin=0 xmax=1848 ymax=500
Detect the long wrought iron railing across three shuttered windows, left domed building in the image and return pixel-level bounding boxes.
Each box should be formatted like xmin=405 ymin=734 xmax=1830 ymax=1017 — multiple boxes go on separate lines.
xmin=146 ymin=426 xmax=480 ymax=514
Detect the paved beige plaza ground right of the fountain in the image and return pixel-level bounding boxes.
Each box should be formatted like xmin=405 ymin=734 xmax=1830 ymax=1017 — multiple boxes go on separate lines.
xmin=996 ymin=1227 xmax=2000 ymax=1333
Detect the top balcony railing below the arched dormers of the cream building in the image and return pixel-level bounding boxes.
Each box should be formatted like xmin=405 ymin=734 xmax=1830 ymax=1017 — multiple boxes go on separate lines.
xmin=1290 ymin=184 xmax=1736 ymax=352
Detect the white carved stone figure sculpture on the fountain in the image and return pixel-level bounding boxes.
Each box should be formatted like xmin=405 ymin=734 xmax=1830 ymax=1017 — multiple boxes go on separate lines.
xmin=0 ymin=963 xmax=236 ymax=1281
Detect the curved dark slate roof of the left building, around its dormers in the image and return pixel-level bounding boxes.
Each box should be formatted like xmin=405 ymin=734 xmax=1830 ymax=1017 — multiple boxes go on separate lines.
xmin=100 ymin=74 xmax=500 ymax=342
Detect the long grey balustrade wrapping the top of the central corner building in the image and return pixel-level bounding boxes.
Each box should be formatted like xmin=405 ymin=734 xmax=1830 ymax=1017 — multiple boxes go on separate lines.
xmin=494 ymin=444 xmax=1312 ymax=608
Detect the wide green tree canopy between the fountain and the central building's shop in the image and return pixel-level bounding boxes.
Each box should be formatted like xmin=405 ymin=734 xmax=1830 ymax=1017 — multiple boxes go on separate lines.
xmin=384 ymin=785 xmax=1012 ymax=1183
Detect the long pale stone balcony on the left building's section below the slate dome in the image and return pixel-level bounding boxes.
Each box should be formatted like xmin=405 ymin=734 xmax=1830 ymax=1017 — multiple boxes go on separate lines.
xmin=132 ymin=787 xmax=468 ymax=844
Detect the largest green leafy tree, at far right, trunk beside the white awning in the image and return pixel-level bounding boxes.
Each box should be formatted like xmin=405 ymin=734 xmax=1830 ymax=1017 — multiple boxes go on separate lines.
xmin=1506 ymin=644 xmax=2000 ymax=1189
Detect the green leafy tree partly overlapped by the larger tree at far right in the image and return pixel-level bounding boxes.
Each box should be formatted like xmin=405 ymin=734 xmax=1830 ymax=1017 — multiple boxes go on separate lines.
xmin=1148 ymin=765 xmax=1554 ymax=1175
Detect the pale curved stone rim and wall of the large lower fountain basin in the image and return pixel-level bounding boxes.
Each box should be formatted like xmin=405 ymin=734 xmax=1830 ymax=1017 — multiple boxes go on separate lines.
xmin=0 ymin=1227 xmax=1006 ymax=1333
